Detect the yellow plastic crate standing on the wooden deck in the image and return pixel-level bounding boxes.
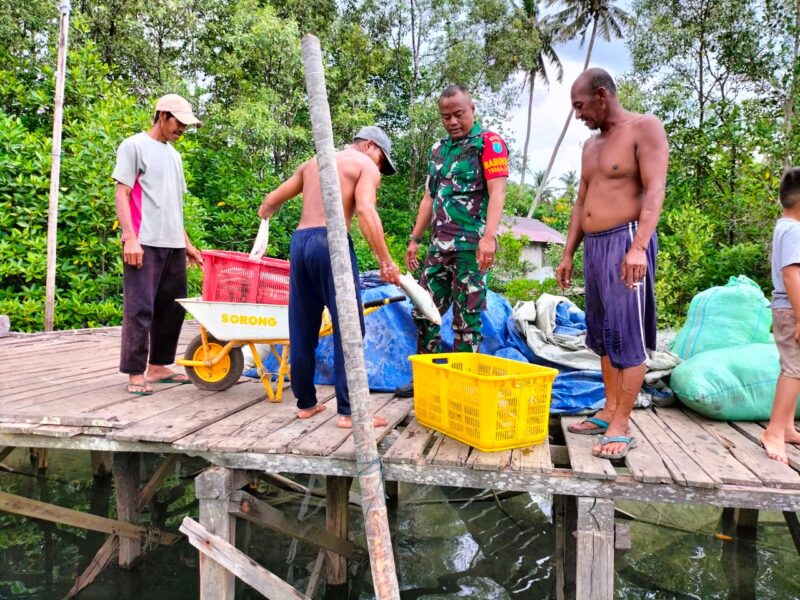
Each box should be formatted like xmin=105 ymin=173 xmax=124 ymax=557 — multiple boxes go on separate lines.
xmin=409 ymin=352 xmax=558 ymax=452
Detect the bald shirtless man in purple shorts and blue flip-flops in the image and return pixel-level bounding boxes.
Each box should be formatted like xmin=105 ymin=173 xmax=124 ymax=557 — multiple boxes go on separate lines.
xmin=556 ymin=69 xmax=669 ymax=459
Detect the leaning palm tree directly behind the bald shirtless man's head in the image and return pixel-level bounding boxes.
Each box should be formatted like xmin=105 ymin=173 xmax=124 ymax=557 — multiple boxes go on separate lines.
xmin=528 ymin=0 xmax=631 ymax=217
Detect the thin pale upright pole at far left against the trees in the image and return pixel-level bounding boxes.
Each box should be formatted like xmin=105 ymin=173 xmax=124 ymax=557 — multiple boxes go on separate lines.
xmin=44 ymin=0 xmax=70 ymax=331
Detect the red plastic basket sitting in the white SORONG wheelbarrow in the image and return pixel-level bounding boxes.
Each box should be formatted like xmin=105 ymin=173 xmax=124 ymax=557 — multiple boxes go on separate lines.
xmin=202 ymin=250 xmax=289 ymax=305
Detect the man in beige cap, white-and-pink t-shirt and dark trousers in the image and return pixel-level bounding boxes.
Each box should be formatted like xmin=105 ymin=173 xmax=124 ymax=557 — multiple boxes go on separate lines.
xmin=111 ymin=94 xmax=203 ymax=395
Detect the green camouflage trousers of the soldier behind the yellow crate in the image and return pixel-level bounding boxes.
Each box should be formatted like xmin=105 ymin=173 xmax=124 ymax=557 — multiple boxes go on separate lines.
xmin=411 ymin=248 xmax=486 ymax=354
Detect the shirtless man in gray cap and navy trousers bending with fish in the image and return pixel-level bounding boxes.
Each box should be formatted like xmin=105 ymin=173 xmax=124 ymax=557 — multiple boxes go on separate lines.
xmin=258 ymin=126 xmax=400 ymax=427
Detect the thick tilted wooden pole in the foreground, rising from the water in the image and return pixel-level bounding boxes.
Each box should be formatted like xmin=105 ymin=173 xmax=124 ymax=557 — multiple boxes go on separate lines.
xmin=303 ymin=35 xmax=400 ymax=600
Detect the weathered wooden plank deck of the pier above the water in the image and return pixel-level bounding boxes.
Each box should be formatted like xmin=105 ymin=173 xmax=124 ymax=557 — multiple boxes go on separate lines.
xmin=0 ymin=323 xmax=800 ymax=511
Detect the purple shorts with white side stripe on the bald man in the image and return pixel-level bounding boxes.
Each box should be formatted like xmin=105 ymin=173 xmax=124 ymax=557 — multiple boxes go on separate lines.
xmin=583 ymin=222 xmax=658 ymax=369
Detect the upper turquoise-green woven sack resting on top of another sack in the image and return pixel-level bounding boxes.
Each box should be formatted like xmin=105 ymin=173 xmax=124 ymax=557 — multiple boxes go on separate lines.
xmin=672 ymin=275 xmax=772 ymax=359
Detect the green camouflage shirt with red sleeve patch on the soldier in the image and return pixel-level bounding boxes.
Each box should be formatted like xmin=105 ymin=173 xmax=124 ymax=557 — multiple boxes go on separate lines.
xmin=427 ymin=123 xmax=508 ymax=252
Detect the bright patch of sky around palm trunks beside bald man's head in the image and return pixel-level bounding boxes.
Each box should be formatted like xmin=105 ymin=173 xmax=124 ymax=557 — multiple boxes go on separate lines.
xmin=503 ymin=28 xmax=631 ymax=187
